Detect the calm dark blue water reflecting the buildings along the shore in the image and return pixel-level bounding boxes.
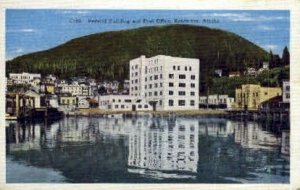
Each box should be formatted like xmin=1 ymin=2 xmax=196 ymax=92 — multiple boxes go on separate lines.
xmin=6 ymin=116 xmax=290 ymax=183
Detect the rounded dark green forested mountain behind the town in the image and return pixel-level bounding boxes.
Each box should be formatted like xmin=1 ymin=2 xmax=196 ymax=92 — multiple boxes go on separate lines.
xmin=6 ymin=25 xmax=268 ymax=93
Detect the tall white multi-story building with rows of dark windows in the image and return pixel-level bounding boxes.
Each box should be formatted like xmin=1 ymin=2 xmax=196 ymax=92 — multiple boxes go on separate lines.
xmin=130 ymin=55 xmax=200 ymax=110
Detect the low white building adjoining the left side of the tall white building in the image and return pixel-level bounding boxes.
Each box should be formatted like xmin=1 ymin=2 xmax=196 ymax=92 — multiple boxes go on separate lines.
xmin=99 ymin=95 xmax=152 ymax=111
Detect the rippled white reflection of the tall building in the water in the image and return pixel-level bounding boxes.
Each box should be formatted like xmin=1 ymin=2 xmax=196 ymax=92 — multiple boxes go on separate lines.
xmin=128 ymin=119 xmax=199 ymax=177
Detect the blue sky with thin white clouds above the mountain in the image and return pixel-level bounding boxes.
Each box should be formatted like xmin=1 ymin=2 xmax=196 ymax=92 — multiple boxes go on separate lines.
xmin=5 ymin=9 xmax=290 ymax=60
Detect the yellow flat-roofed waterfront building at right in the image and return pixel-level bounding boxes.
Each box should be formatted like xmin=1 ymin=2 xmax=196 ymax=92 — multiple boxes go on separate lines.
xmin=235 ymin=84 xmax=282 ymax=110
